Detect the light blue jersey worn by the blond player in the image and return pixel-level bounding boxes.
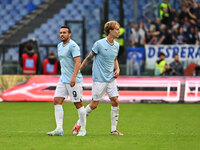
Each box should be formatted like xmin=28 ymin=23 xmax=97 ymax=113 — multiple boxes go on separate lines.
xmin=92 ymin=38 xmax=119 ymax=82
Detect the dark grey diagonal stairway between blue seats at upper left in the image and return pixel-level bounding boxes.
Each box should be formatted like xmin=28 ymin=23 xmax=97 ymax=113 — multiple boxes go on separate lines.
xmin=0 ymin=0 xmax=71 ymax=44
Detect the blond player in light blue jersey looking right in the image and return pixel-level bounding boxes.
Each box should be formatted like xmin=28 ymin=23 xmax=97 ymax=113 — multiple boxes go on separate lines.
xmin=73 ymin=21 xmax=123 ymax=135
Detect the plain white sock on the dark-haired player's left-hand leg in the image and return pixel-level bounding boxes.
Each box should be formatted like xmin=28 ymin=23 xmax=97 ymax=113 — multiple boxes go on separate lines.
xmin=54 ymin=105 xmax=64 ymax=130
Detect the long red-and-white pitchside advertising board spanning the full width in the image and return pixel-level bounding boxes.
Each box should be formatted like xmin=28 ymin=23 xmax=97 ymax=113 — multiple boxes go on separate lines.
xmin=0 ymin=75 xmax=200 ymax=103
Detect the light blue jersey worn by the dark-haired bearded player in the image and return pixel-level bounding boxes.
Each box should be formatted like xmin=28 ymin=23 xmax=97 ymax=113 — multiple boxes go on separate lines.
xmin=57 ymin=40 xmax=83 ymax=83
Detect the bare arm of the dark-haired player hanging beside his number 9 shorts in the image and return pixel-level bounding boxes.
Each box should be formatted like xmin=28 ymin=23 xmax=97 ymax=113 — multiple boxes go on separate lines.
xmin=70 ymin=56 xmax=81 ymax=87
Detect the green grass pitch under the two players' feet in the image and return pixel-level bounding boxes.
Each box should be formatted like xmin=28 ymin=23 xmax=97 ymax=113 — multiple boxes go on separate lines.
xmin=0 ymin=102 xmax=200 ymax=150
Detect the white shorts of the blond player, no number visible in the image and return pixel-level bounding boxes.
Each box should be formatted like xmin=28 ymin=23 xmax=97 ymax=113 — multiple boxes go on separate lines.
xmin=92 ymin=80 xmax=119 ymax=101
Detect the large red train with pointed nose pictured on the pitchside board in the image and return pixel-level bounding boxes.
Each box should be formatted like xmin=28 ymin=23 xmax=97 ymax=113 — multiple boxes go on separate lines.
xmin=1 ymin=75 xmax=181 ymax=102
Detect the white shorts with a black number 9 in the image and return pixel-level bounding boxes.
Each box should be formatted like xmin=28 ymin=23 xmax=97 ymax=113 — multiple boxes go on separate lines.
xmin=54 ymin=82 xmax=83 ymax=102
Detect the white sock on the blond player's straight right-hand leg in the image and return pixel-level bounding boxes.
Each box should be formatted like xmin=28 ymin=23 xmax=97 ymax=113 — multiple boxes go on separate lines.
xmin=111 ymin=106 xmax=119 ymax=131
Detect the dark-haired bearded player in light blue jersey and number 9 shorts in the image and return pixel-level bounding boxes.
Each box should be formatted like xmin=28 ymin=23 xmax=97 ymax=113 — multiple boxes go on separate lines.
xmin=47 ymin=26 xmax=87 ymax=136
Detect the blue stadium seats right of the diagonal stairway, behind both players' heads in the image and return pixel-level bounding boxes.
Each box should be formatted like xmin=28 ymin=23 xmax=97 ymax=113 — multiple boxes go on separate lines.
xmin=18 ymin=0 xmax=133 ymax=56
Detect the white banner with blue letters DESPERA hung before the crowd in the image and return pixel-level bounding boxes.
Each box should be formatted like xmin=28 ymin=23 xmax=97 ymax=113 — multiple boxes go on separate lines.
xmin=145 ymin=45 xmax=200 ymax=69
